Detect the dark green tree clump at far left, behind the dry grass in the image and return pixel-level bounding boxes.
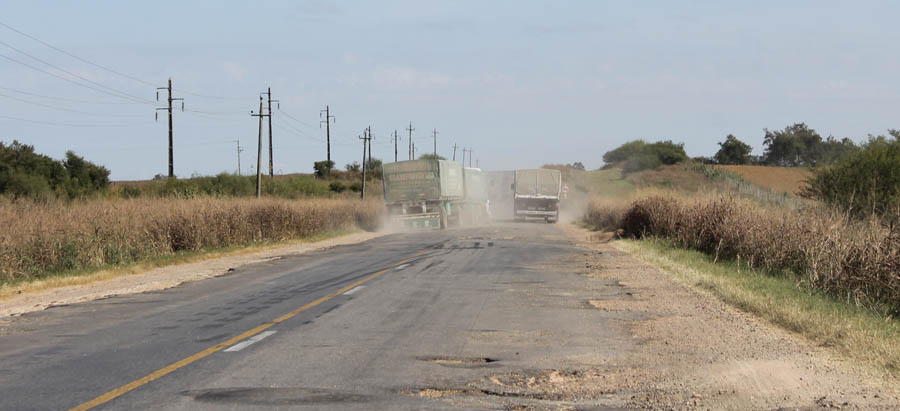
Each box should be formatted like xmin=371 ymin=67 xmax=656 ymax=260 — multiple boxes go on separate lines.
xmin=0 ymin=140 xmax=109 ymax=198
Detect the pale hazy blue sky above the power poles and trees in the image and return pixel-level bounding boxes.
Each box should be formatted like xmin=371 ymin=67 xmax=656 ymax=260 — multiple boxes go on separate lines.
xmin=0 ymin=0 xmax=900 ymax=180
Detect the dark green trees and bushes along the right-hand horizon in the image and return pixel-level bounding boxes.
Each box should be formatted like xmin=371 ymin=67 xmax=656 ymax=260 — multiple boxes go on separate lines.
xmin=603 ymin=123 xmax=900 ymax=217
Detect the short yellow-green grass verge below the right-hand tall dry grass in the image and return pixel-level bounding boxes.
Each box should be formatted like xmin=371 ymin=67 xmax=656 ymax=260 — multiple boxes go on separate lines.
xmin=612 ymin=238 xmax=900 ymax=381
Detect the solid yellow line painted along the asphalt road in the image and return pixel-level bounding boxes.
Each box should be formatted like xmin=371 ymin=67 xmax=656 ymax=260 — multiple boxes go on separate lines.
xmin=70 ymin=251 xmax=427 ymax=411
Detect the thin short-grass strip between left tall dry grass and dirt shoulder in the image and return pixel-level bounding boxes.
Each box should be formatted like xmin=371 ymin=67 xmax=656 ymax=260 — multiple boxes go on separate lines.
xmin=0 ymin=229 xmax=362 ymax=301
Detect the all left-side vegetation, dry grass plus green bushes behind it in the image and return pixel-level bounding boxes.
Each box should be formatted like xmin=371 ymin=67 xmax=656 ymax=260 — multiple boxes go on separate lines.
xmin=0 ymin=141 xmax=382 ymax=286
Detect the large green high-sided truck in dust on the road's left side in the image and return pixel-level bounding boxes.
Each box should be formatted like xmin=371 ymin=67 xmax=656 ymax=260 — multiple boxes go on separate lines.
xmin=382 ymin=160 xmax=466 ymax=229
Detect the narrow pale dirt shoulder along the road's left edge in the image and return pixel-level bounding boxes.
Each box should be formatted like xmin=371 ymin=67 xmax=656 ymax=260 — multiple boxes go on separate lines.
xmin=0 ymin=232 xmax=385 ymax=318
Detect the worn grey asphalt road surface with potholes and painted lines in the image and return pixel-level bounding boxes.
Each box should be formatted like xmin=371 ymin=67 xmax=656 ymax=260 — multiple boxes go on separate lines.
xmin=0 ymin=223 xmax=634 ymax=410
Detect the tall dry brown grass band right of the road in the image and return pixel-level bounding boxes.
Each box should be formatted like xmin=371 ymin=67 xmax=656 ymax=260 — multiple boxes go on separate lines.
xmin=586 ymin=193 xmax=900 ymax=316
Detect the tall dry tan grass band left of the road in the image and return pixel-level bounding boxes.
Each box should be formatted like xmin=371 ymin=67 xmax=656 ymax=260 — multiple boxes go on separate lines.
xmin=0 ymin=198 xmax=382 ymax=282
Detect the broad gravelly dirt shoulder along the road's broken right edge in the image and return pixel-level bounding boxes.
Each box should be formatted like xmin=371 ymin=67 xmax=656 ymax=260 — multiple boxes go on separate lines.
xmin=560 ymin=225 xmax=900 ymax=409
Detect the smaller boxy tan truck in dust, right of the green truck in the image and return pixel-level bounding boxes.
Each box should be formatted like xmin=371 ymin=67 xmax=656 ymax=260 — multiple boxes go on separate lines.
xmin=513 ymin=168 xmax=562 ymax=223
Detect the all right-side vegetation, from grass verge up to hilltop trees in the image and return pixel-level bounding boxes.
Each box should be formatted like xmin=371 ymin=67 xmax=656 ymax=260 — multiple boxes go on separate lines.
xmin=570 ymin=123 xmax=900 ymax=378
